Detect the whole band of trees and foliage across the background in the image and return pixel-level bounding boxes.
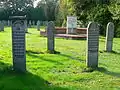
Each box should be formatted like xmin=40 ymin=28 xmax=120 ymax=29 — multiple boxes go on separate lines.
xmin=0 ymin=0 xmax=120 ymax=37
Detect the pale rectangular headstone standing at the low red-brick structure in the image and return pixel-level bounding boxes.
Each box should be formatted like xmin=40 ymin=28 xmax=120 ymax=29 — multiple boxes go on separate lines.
xmin=67 ymin=16 xmax=77 ymax=34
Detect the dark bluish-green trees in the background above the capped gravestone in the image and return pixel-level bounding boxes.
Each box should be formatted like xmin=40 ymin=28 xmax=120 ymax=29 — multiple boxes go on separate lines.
xmin=0 ymin=0 xmax=58 ymax=21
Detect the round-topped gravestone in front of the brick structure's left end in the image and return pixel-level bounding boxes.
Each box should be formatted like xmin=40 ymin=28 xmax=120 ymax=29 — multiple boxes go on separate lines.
xmin=47 ymin=21 xmax=55 ymax=53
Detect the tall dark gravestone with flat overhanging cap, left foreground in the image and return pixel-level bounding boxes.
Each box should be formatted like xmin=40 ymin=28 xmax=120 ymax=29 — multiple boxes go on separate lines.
xmin=10 ymin=16 xmax=26 ymax=72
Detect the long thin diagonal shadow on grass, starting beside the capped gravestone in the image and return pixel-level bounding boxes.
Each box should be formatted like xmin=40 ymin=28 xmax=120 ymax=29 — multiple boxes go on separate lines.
xmin=27 ymin=51 xmax=63 ymax=65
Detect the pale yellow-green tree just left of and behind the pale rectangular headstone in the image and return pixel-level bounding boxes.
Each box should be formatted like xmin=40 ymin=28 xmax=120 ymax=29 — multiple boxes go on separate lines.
xmin=56 ymin=0 xmax=75 ymax=26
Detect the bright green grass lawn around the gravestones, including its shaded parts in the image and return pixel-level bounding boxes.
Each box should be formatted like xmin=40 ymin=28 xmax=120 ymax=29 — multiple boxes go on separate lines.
xmin=0 ymin=27 xmax=120 ymax=90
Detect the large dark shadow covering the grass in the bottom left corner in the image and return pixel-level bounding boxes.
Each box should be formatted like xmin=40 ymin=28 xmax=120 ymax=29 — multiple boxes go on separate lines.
xmin=0 ymin=62 xmax=68 ymax=90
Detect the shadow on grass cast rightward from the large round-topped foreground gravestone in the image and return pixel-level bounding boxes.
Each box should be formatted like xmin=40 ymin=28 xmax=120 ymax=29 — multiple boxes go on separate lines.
xmin=97 ymin=67 xmax=120 ymax=78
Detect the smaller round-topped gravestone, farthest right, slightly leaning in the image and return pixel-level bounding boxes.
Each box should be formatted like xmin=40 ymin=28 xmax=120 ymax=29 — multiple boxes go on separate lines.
xmin=105 ymin=22 xmax=114 ymax=52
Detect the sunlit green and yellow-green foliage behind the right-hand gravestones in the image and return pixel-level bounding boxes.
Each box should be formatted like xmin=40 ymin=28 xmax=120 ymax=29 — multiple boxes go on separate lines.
xmin=57 ymin=0 xmax=120 ymax=37
